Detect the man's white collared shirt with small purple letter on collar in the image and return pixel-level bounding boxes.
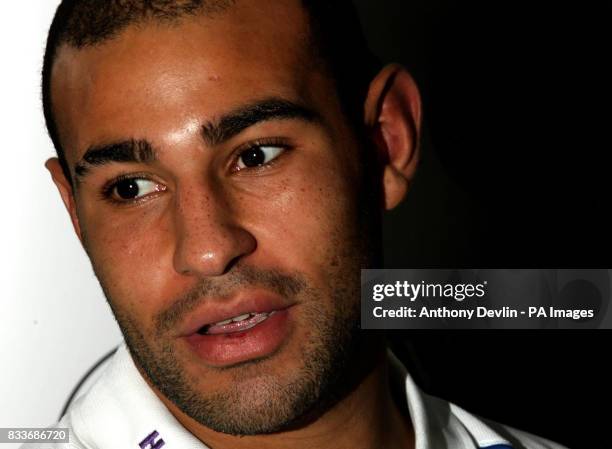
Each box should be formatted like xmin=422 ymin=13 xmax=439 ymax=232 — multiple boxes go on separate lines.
xmin=21 ymin=343 xmax=566 ymax=449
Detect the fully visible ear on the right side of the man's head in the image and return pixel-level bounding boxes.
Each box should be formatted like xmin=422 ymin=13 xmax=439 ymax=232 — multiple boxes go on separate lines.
xmin=365 ymin=64 xmax=421 ymax=210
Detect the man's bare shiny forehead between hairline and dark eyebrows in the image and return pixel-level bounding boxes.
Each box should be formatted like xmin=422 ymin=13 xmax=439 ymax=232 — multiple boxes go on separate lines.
xmin=51 ymin=0 xmax=332 ymax=159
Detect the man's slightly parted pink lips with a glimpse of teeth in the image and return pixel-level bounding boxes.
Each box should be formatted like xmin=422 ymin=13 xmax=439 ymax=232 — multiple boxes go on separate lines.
xmin=177 ymin=292 xmax=292 ymax=367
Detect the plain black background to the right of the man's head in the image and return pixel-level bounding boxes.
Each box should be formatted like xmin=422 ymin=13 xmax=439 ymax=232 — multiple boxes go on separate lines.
xmin=355 ymin=0 xmax=612 ymax=449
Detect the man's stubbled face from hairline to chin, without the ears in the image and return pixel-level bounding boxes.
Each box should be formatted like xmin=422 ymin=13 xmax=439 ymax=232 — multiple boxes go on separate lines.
xmin=52 ymin=1 xmax=380 ymax=434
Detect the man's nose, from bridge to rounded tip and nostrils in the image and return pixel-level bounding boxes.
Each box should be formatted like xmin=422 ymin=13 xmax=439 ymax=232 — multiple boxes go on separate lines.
xmin=173 ymin=182 xmax=257 ymax=277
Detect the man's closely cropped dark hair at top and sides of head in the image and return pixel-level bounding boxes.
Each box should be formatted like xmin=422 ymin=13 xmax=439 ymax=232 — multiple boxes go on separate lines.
xmin=42 ymin=0 xmax=380 ymax=182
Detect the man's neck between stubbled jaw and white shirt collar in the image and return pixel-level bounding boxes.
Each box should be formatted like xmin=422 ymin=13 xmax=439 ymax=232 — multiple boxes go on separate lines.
xmin=156 ymin=344 xmax=414 ymax=449
